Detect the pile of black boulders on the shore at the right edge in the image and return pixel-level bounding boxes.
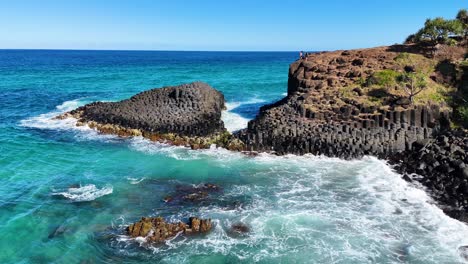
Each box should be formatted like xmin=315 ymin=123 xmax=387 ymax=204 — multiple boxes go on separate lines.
xmin=388 ymin=131 xmax=468 ymax=222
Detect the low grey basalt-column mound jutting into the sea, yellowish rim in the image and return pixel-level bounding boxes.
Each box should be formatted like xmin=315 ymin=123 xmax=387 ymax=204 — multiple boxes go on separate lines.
xmin=58 ymin=82 xmax=242 ymax=150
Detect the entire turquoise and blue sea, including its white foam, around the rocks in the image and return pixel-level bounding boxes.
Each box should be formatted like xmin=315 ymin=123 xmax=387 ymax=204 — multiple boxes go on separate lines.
xmin=0 ymin=51 xmax=468 ymax=263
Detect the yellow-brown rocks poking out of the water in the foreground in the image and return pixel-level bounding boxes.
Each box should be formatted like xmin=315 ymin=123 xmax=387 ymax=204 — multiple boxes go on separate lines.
xmin=127 ymin=217 xmax=212 ymax=242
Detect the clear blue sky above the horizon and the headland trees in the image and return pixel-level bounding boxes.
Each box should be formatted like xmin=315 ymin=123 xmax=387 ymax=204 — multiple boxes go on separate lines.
xmin=0 ymin=0 xmax=468 ymax=51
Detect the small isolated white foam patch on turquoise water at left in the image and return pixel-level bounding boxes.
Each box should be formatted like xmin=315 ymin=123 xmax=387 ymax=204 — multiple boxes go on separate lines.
xmin=52 ymin=184 xmax=113 ymax=202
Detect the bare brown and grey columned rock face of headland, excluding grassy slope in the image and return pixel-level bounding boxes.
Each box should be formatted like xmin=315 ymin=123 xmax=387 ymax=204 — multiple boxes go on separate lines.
xmin=237 ymin=47 xmax=448 ymax=158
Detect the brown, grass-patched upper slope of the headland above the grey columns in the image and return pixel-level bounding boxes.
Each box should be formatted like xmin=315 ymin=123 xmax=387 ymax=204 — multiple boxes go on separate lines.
xmin=290 ymin=45 xmax=462 ymax=116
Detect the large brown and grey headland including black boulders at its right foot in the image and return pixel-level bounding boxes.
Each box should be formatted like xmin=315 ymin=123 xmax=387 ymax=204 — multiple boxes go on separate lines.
xmin=236 ymin=45 xmax=468 ymax=221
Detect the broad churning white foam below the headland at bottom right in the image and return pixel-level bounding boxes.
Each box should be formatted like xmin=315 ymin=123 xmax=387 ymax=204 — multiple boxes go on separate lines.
xmin=112 ymin=156 xmax=468 ymax=263
